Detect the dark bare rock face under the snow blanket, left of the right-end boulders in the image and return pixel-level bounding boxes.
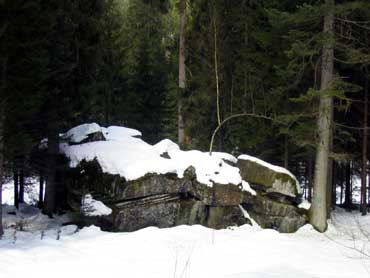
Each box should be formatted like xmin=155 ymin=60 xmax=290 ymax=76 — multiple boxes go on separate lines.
xmin=68 ymin=161 xmax=251 ymax=231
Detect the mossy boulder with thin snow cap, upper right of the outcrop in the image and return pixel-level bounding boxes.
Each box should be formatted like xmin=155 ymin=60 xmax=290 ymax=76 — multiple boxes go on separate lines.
xmin=237 ymin=155 xmax=302 ymax=198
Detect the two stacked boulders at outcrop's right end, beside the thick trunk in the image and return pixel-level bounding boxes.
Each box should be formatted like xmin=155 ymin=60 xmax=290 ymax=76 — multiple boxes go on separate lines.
xmin=237 ymin=155 xmax=307 ymax=233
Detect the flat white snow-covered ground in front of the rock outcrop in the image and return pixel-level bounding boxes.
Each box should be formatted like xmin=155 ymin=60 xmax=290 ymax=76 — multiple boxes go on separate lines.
xmin=0 ymin=207 xmax=370 ymax=278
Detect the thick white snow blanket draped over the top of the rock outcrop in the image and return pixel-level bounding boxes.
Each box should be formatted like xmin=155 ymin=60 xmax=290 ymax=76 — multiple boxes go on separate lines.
xmin=60 ymin=124 xmax=241 ymax=186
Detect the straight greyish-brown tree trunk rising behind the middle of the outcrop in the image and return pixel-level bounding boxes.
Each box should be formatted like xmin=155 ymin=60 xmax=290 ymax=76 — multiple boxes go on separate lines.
xmin=177 ymin=0 xmax=186 ymax=146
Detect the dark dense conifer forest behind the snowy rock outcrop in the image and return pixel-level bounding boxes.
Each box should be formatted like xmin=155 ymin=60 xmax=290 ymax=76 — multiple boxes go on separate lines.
xmin=0 ymin=0 xmax=370 ymax=233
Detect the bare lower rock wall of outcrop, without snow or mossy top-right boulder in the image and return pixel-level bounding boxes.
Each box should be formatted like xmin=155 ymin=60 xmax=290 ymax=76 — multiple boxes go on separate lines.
xmin=68 ymin=156 xmax=306 ymax=233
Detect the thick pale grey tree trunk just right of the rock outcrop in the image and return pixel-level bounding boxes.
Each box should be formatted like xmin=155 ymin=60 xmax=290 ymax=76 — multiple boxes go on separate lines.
xmin=310 ymin=0 xmax=334 ymax=232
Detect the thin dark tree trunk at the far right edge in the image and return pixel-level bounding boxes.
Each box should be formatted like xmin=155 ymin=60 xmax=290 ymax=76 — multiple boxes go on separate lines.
xmin=361 ymin=78 xmax=369 ymax=215
